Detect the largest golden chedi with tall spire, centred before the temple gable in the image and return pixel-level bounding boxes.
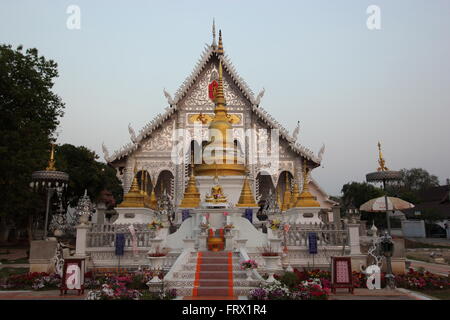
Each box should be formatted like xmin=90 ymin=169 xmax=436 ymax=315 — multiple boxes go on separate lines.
xmin=195 ymin=48 xmax=245 ymax=176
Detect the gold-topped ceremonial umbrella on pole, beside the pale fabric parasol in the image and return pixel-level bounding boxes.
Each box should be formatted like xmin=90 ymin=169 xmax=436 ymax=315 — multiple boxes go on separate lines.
xmin=366 ymin=142 xmax=402 ymax=289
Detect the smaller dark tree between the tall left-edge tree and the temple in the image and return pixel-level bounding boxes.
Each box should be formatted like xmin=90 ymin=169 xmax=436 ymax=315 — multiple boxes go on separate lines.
xmin=55 ymin=144 xmax=123 ymax=206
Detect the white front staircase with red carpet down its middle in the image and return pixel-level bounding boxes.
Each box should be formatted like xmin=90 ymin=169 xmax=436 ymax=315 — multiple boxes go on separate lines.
xmin=170 ymin=251 xmax=259 ymax=299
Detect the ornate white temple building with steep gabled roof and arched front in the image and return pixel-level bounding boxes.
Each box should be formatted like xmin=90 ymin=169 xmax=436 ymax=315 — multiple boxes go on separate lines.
xmin=103 ymin=25 xmax=334 ymax=211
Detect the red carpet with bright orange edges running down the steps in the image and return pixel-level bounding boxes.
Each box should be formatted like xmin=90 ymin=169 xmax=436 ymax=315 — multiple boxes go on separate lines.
xmin=190 ymin=251 xmax=235 ymax=300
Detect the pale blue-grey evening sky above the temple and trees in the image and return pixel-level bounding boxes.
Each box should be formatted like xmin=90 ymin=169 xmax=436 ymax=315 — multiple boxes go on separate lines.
xmin=0 ymin=0 xmax=450 ymax=195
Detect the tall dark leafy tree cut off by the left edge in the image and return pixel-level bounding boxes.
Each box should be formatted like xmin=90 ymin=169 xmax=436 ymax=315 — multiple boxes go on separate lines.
xmin=0 ymin=45 xmax=64 ymax=240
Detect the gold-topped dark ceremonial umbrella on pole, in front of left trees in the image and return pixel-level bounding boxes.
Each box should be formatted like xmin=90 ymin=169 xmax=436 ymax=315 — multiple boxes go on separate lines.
xmin=30 ymin=144 xmax=69 ymax=240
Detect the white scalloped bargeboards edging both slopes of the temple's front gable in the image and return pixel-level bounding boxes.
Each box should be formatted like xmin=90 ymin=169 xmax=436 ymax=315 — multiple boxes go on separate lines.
xmin=105 ymin=37 xmax=321 ymax=166
